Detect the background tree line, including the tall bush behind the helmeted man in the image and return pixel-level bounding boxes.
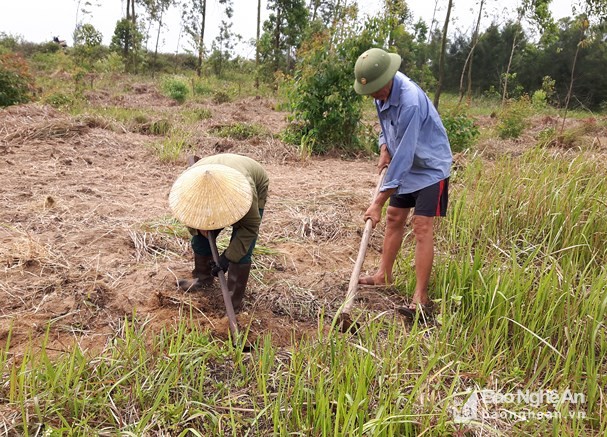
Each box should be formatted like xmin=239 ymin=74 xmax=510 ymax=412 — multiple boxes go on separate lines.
xmin=0 ymin=0 xmax=607 ymax=153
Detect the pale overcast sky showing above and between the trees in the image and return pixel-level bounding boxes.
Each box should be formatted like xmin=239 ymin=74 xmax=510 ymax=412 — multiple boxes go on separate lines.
xmin=0 ymin=0 xmax=576 ymax=57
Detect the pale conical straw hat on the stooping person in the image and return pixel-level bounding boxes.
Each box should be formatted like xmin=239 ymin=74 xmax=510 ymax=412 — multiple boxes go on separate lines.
xmin=169 ymin=164 xmax=253 ymax=231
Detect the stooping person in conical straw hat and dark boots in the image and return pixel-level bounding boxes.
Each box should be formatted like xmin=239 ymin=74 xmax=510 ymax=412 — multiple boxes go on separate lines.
xmin=169 ymin=153 xmax=269 ymax=312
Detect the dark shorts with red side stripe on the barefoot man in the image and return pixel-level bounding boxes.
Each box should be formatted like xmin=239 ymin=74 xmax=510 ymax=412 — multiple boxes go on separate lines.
xmin=390 ymin=178 xmax=449 ymax=217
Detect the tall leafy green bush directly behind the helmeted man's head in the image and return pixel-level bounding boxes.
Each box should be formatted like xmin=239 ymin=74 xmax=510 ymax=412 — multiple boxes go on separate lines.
xmin=285 ymin=17 xmax=383 ymax=155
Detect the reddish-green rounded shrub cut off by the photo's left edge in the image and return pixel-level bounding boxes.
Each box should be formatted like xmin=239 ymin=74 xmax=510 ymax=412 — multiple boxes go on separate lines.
xmin=0 ymin=53 xmax=34 ymax=107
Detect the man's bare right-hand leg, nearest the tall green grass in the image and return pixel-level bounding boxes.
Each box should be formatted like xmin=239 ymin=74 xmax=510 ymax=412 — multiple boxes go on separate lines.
xmin=413 ymin=216 xmax=434 ymax=305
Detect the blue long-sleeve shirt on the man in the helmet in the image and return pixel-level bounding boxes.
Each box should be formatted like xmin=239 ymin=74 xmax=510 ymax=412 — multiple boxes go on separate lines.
xmin=375 ymin=72 xmax=453 ymax=194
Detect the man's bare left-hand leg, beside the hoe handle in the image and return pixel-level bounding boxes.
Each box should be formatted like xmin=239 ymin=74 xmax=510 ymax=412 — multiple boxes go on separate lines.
xmin=358 ymin=206 xmax=411 ymax=285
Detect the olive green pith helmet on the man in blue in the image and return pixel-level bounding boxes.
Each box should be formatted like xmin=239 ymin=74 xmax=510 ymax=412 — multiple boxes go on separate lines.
xmin=354 ymin=48 xmax=401 ymax=95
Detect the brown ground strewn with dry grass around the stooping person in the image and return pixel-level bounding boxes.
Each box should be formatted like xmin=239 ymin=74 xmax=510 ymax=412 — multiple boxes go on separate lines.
xmin=0 ymin=86 xmax=416 ymax=356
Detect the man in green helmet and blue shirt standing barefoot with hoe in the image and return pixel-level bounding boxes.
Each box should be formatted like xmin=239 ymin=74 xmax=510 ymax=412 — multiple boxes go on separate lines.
xmin=354 ymin=48 xmax=452 ymax=317
